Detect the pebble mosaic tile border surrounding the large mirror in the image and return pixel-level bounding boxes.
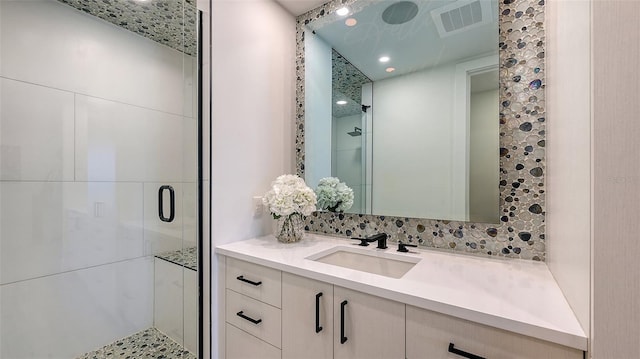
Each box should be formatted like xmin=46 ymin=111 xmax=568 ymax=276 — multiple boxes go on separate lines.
xmin=296 ymin=0 xmax=546 ymax=261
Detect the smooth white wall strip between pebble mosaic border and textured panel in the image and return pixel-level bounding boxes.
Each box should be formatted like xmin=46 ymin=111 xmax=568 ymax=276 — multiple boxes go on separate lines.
xmin=546 ymin=0 xmax=592 ymax=333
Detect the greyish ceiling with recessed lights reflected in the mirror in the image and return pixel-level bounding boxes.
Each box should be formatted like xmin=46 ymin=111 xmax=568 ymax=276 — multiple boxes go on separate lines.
xmin=309 ymin=0 xmax=498 ymax=81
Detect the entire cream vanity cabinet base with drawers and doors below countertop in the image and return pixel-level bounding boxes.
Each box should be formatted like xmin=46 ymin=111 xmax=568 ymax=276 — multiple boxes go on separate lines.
xmin=225 ymin=249 xmax=583 ymax=359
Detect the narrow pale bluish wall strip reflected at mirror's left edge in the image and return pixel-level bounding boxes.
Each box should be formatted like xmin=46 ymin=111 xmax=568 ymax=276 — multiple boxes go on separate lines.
xmin=304 ymin=31 xmax=333 ymax=188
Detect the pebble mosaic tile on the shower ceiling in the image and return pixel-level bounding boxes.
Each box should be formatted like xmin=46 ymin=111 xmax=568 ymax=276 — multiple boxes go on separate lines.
xmin=58 ymin=0 xmax=198 ymax=56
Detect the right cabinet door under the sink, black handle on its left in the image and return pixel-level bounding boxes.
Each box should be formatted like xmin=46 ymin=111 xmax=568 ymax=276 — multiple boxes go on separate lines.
xmin=333 ymin=286 xmax=405 ymax=359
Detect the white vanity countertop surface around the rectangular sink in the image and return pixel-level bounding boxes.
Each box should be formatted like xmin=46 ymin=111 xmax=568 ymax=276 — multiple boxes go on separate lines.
xmin=215 ymin=233 xmax=587 ymax=350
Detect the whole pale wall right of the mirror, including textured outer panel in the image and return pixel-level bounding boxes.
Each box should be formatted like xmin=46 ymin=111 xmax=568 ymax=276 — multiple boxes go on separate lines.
xmin=547 ymin=1 xmax=640 ymax=359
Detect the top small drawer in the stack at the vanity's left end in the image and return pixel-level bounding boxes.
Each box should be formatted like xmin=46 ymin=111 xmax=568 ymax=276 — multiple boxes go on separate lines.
xmin=226 ymin=257 xmax=282 ymax=308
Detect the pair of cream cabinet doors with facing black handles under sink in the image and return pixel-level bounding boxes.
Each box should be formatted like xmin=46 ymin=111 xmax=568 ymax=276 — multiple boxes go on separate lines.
xmin=282 ymin=273 xmax=405 ymax=359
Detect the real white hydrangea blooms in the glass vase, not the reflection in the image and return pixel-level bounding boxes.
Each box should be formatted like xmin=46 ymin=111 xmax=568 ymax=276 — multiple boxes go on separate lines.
xmin=262 ymin=175 xmax=317 ymax=218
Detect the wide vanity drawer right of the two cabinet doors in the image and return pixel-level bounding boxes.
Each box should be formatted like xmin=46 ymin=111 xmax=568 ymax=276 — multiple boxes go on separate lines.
xmin=406 ymin=305 xmax=582 ymax=359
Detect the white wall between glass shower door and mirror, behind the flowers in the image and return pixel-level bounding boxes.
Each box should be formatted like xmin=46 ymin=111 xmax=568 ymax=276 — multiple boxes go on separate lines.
xmin=211 ymin=0 xmax=295 ymax=357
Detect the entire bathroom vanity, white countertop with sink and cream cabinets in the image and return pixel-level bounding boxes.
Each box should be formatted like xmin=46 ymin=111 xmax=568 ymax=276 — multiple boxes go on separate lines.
xmin=216 ymin=233 xmax=587 ymax=359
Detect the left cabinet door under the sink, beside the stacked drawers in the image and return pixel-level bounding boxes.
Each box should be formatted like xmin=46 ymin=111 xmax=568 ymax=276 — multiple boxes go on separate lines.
xmin=282 ymin=273 xmax=333 ymax=359
